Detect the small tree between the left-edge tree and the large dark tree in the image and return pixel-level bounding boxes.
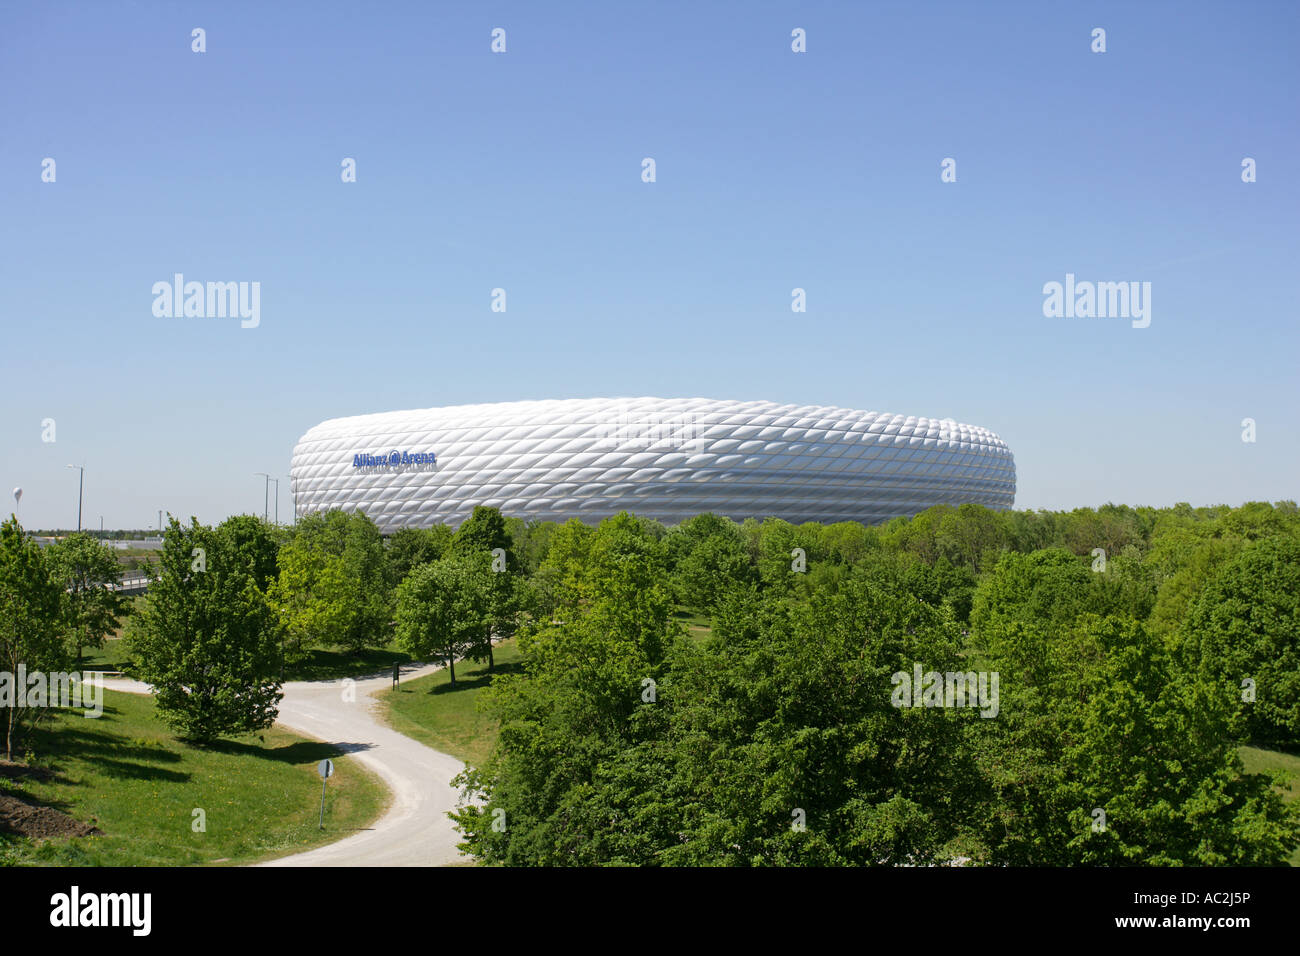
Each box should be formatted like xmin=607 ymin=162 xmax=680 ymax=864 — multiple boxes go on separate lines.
xmin=46 ymin=532 xmax=129 ymax=665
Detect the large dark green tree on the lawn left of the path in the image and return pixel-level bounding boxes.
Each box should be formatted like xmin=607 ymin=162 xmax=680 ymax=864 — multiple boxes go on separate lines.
xmin=130 ymin=515 xmax=282 ymax=743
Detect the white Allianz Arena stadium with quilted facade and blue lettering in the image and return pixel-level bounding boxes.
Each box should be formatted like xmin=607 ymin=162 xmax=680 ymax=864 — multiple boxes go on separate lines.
xmin=290 ymin=398 xmax=1015 ymax=533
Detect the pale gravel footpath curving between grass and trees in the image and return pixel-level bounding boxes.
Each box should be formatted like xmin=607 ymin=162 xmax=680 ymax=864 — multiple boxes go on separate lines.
xmin=104 ymin=665 xmax=469 ymax=866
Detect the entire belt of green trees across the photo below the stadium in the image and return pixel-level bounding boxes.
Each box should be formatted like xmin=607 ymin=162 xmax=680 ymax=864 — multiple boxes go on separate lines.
xmin=0 ymin=502 xmax=1300 ymax=865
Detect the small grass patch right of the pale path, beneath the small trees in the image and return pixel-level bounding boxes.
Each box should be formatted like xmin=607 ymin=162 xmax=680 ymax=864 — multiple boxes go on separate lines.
xmin=377 ymin=639 xmax=521 ymax=766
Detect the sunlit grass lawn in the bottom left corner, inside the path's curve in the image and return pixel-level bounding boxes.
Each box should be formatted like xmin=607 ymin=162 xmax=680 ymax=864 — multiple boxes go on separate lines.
xmin=0 ymin=691 xmax=389 ymax=866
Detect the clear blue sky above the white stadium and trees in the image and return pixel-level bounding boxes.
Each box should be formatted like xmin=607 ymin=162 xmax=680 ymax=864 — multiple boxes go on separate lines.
xmin=0 ymin=1 xmax=1300 ymax=527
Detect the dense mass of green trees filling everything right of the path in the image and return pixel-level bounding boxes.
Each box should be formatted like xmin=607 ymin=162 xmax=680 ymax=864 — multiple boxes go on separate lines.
xmin=458 ymin=502 xmax=1300 ymax=865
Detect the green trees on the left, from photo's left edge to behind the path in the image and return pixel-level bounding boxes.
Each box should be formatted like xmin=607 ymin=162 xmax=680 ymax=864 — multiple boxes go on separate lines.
xmin=0 ymin=509 xmax=527 ymax=760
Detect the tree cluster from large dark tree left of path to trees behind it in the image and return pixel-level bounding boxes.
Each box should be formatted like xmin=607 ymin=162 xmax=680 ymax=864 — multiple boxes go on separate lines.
xmin=120 ymin=509 xmax=524 ymax=741
